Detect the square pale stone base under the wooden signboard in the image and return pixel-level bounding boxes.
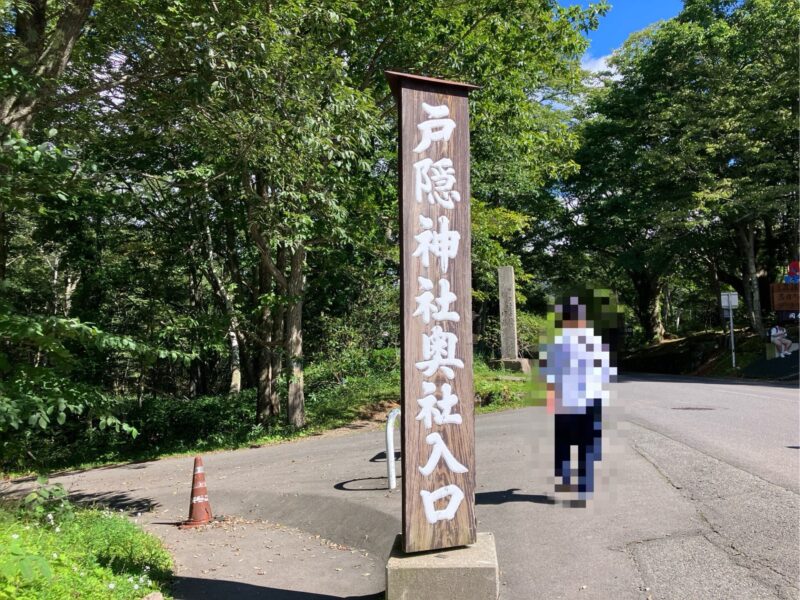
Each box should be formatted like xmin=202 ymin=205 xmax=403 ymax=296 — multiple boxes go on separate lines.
xmin=386 ymin=533 xmax=500 ymax=600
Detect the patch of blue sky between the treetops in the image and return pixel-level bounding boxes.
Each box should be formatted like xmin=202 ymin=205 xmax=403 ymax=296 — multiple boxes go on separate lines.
xmin=559 ymin=0 xmax=683 ymax=70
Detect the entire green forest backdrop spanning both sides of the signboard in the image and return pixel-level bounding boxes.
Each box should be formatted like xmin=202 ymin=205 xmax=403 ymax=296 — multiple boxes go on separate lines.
xmin=0 ymin=0 xmax=800 ymax=472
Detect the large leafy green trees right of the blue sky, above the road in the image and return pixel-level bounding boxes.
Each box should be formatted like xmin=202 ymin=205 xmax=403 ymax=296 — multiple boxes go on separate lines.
xmin=565 ymin=0 xmax=800 ymax=339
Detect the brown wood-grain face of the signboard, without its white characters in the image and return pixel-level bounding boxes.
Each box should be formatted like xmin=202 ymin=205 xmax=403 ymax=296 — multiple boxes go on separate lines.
xmin=398 ymin=80 xmax=476 ymax=552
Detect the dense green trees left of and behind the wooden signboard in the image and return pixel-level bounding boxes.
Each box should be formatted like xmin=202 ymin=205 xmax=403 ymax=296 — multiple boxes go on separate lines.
xmin=0 ymin=0 xmax=605 ymax=468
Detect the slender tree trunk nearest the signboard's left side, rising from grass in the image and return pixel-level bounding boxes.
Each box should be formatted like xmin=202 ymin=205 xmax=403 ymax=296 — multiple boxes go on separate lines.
xmin=285 ymin=246 xmax=306 ymax=427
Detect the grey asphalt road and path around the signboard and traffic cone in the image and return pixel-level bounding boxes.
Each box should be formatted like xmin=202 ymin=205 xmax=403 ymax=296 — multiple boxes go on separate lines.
xmin=7 ymin=377 xmax=800 ymax=600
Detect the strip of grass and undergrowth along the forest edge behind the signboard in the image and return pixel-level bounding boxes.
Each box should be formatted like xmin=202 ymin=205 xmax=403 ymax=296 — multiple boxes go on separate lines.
xmin=0 ymin=349 xmax=540 ymax=476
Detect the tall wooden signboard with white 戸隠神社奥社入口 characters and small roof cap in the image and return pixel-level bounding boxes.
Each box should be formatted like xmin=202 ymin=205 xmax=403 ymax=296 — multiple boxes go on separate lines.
xmin=386 ymin=71 xmax=476 ymax=552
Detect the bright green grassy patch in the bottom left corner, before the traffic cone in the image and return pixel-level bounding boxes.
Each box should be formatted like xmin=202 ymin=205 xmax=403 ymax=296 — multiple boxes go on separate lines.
xmin=0 ymin=492 xmax=172 ymax=600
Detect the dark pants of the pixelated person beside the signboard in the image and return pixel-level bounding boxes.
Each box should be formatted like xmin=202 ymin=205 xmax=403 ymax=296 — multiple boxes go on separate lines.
xmin=555 ymin=400 xmax=603 ymax=493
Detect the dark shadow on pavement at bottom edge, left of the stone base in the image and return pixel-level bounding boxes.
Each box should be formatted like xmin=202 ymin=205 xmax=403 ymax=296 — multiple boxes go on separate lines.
xmin=172 ymin=577 xmax=383 ymax=600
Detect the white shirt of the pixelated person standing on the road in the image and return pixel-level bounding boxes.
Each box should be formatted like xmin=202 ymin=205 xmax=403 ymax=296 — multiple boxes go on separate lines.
xmin=539 ymin=327 xmax=617 ymax=414
